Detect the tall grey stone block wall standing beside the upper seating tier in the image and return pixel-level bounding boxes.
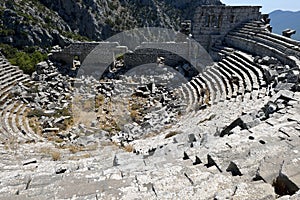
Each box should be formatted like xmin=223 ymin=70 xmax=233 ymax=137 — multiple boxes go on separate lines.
xmin=192 ymin=6 xmax=261 ymax=50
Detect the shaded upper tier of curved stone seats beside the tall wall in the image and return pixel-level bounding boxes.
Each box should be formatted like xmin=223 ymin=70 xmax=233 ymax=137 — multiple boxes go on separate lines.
xmin=225 ymin=20 xmax=300 ymax=67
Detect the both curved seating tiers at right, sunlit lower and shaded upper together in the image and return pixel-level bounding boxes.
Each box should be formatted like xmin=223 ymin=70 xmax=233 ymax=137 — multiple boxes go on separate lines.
xmin=176 ymin=18 xmax=300 ymax=115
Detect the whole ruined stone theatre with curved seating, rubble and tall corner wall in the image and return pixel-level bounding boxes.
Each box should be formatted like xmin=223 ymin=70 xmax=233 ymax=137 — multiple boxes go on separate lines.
xmin=0 ymin=3 xmax=300 ymax=200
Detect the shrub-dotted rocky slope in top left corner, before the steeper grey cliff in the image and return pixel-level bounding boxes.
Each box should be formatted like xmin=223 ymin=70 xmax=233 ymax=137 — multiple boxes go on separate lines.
xmin=0 ymin=1 xmax=71 ymax=47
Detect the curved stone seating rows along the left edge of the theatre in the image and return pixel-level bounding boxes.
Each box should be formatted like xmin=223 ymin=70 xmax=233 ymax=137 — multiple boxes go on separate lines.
xmin=0 ymin=54 xmax=38 ymax=143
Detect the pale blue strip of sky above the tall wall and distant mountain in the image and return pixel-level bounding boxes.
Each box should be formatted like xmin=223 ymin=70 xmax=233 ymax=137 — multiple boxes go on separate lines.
xmin=221 ymin=0 xmax=300 ymax=14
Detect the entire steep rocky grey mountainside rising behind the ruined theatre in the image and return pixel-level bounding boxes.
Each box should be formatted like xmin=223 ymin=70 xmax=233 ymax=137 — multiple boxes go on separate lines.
xmin=0 ymin=0 xmax=221 ymax=47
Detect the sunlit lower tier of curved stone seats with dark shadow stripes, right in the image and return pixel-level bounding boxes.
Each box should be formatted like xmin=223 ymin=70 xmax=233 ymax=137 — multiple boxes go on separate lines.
xmin=178 ymin=48 xmax=267 ymax=112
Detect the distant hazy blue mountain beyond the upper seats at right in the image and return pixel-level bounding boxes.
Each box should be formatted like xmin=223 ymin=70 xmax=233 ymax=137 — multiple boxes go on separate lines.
xmin=270 ymin=10 xmax=300 ymax=41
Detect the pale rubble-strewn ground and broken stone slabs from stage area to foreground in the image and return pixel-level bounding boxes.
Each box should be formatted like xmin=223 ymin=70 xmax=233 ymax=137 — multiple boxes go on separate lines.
xmin=0 ymin=46 xmax=300 ymax=199
